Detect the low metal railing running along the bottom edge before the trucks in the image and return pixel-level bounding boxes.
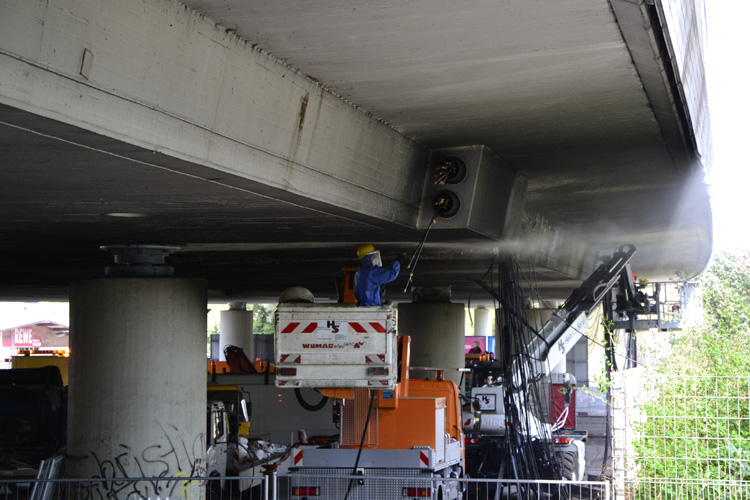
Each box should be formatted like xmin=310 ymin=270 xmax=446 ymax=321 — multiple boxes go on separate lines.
xmin=0 ymin=474 xmax=611 ymax=500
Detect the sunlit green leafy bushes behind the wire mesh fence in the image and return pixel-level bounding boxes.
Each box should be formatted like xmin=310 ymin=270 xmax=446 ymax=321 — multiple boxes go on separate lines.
xmin=635 ymin=252 xmax=750 ymax=499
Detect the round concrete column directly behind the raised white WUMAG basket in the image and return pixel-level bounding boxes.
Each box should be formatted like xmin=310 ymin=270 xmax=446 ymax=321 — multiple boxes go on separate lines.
xmin=398 ymin=302 xmax=465 ymax=384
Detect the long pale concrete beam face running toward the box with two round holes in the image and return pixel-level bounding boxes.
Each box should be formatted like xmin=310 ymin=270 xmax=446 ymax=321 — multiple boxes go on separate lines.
xmin=0 ymin=0 xmax=426 ymax=227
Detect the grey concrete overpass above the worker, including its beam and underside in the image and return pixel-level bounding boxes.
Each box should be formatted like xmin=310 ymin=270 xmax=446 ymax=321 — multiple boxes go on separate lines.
xmin=0 ymin=0 xmax=712 ymax=302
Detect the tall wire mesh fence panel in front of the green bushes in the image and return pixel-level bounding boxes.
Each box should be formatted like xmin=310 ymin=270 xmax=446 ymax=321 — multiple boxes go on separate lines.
xmin=618 ymin=375 xmax=750 ymax=500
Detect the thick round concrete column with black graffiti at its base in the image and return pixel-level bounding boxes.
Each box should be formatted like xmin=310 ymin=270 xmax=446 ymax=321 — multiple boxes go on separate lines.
xmin=67 ymin=278 xmax=207 ymax=499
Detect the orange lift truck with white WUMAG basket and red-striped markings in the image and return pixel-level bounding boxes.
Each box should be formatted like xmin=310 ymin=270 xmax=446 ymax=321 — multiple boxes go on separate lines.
xmin=275 ymin=304 xmax=464 ymax=500
